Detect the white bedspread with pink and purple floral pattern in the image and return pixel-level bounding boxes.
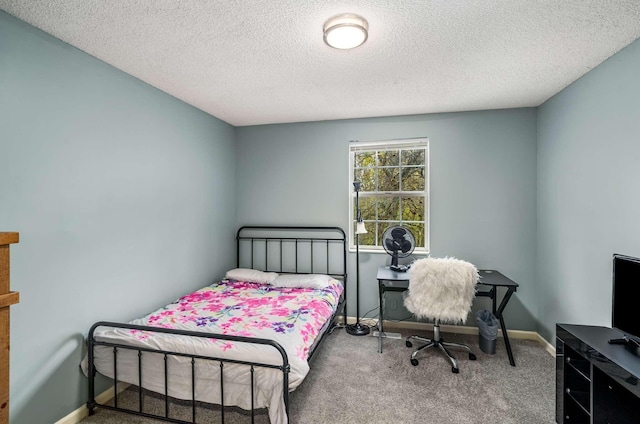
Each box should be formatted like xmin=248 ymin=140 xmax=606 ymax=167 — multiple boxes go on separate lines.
xmin=127 ymin=280 xmax=342 ymax=360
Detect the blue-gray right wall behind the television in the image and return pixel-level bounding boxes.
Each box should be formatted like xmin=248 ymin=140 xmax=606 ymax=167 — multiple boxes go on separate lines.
xmin=537 ymin=41 xmax=640 ymax=340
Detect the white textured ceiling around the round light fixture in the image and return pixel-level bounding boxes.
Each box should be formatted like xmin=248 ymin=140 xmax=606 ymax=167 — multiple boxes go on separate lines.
xmin=0 ymin=0 xmax=640 ymax=126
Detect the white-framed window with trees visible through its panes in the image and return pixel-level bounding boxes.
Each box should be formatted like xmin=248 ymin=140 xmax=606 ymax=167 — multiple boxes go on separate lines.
xmin=349 ymin=138 xmax=429 ymax=253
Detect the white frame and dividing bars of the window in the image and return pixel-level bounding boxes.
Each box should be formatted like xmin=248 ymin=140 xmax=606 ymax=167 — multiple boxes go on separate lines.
xmin=348 ymin=137 xmax=431 ymax=254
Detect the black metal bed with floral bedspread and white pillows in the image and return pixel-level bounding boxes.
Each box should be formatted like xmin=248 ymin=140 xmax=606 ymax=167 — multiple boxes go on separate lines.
xmin=84 ymin=226 xmax=347 ymax=424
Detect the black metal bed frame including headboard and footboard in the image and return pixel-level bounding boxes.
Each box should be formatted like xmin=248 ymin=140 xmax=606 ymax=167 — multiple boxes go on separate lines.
xmin=87 ymin=226 xmax=347 ymax=424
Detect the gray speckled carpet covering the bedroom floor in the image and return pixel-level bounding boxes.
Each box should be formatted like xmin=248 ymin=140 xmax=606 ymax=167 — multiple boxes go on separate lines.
xmin=82 ymin=329 xmax=555 ymax=424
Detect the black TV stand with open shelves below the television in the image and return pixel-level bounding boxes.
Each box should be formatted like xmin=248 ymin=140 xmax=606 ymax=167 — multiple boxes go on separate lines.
xmin=556 ymin=324 xmax=640 ymax=424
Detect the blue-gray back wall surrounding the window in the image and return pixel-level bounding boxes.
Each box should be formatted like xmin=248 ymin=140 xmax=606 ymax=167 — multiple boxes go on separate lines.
xmin=237 ymin=109 xmax=537 ymax=330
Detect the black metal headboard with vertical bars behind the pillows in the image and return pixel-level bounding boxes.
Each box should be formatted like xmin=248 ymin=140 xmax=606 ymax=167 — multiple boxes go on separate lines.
xmin=236 ymin=226 xmax=347 ymax=286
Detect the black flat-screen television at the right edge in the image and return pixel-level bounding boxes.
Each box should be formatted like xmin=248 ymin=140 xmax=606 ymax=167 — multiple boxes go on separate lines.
xmin=609 ymin=254 xmax=640 ymax=346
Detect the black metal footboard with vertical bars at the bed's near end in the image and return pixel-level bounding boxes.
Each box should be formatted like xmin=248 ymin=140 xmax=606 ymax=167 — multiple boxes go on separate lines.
xmin=87 ymin=321 xmax=290 ymax=423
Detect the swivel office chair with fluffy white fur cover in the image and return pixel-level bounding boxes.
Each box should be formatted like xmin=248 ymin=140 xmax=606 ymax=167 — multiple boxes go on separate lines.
xmin=404 ymin=258 xmax=479 ymax=374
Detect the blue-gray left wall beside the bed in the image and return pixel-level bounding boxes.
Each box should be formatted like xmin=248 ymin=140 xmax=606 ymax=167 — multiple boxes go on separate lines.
xmin=0 ymin=12 xmax=236 ymax=424
